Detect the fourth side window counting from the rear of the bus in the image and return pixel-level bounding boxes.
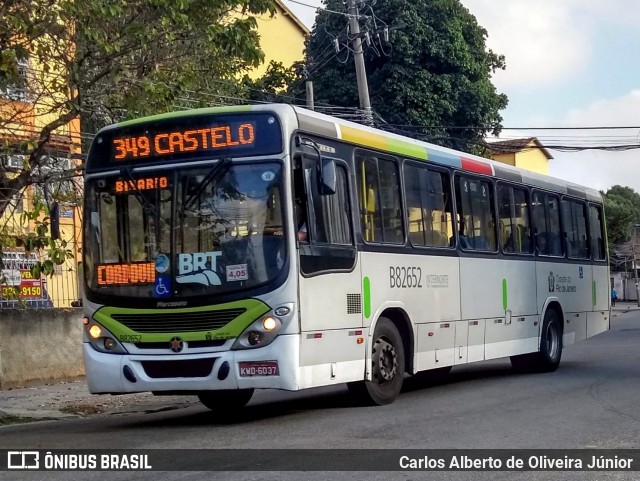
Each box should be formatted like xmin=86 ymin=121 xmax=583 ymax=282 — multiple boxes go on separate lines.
xmin=498 ymin=184 xmax=532 ymax=254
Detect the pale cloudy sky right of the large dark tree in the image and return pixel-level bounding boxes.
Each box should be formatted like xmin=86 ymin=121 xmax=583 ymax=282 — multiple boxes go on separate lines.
xmin=284 ymin=0 xmax=640 ymax=192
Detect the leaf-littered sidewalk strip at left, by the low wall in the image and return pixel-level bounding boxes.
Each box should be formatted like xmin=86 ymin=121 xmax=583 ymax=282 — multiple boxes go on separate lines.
xmin=0 ymin=378 xmax=198 ymax=427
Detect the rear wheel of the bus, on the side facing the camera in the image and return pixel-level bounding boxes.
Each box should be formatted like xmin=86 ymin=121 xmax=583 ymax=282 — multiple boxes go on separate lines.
xmin=511 ymin=309 xmax=562 ymax=372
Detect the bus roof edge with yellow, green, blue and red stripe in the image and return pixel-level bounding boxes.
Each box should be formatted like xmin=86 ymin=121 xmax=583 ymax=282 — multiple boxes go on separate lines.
xmin=102 ymin=104 xmax=602 ymax=202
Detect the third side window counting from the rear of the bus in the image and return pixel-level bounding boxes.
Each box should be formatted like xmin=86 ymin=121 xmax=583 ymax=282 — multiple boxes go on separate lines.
xmin=532 ymin=192 xmax=564 ymax=257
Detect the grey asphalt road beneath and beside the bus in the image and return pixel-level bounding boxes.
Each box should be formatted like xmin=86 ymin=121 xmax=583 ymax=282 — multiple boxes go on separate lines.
xmin=0 ymin=311 xmax=640 ymax=480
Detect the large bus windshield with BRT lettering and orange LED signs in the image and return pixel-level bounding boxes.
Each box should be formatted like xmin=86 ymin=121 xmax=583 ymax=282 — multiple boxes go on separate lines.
xmin=85 ymin=160 xmax=286 ymax=299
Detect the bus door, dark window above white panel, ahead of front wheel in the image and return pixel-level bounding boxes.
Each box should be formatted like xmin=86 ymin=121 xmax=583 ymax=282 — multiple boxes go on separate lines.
xmin=294 ymin=155 xmax=364 ymax=387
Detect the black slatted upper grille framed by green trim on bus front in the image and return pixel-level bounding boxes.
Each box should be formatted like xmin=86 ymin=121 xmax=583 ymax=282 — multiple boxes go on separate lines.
xmin=111 ymin=308 xmax=246 ymax=332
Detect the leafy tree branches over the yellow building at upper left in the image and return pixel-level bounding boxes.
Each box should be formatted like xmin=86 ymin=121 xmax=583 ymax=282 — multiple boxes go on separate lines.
xmin=0 ymin=0 xmax=275 ymax=215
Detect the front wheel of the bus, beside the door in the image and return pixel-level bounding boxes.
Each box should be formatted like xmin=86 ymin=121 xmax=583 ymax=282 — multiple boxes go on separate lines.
xmin=348 ymin=317 xmax=405 ymax=406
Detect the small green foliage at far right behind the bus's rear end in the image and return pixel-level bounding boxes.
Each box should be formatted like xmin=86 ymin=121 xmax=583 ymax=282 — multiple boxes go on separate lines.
xmin=602 ymin=185 xmax=640 ymax=246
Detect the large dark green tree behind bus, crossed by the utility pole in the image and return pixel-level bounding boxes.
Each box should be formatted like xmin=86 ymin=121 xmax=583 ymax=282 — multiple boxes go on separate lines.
xmin=306 ymin=0 xmax=507 ymax=150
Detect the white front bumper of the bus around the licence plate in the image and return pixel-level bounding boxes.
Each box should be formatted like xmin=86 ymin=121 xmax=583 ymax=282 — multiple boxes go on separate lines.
xmin=83 ymin=334 xmax=300 ymax=394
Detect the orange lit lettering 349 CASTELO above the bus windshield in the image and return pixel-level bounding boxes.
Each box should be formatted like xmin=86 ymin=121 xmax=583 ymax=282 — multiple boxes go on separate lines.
xmin=113 ymin=122 xmax=256 ymax=160
